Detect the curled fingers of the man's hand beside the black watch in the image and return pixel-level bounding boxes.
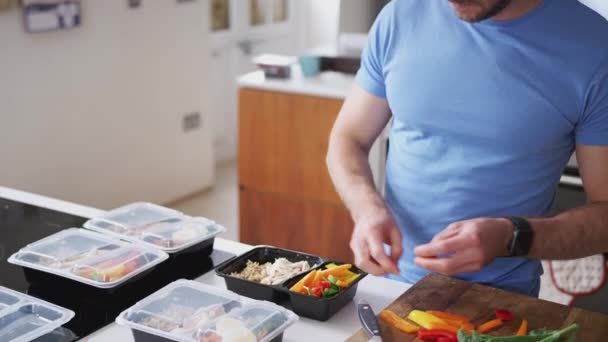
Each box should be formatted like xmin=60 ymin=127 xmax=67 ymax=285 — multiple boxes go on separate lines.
xmin=414 ymin=249 xmax=483 ymax=275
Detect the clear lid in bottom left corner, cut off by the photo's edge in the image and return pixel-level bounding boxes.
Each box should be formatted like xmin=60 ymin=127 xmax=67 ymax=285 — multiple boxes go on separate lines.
xmin=0 ymin=286 xmax=74 ymax=342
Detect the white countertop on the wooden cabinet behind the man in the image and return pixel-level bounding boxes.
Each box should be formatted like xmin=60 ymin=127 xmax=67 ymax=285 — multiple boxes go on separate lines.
xmin=237 ymin=67 xmax=355 ymax=99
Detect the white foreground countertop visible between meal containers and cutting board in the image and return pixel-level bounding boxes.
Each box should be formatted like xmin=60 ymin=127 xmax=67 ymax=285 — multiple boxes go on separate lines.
xmin=0 ymin=187 xmax=411 ymax=342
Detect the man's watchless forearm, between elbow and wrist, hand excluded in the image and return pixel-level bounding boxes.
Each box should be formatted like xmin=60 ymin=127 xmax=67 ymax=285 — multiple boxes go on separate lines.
xmin=327 ymin=140 xmax=384 ymax=221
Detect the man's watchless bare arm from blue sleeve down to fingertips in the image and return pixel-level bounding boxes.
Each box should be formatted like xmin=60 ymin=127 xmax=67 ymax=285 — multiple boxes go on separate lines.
xmin=327 ymin=85 xmax=403 ymax=275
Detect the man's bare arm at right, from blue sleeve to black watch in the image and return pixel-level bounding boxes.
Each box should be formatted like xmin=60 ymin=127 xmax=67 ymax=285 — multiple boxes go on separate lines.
xmin=530 ymin=145 xmax=608 ymax=259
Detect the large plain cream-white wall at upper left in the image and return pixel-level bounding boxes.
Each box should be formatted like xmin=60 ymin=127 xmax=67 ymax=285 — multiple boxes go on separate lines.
xmin=0 ymin=0 xmax=213 ymax=208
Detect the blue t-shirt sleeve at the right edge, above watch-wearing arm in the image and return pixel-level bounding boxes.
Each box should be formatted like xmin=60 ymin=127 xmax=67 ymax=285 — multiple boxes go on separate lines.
xmin=576 ymin=59 xmax=608 ymax=146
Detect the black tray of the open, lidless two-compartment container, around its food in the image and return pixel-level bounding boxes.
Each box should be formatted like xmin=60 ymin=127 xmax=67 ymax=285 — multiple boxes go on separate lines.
xmin=216 ymin=246 xmax=367 ymax=321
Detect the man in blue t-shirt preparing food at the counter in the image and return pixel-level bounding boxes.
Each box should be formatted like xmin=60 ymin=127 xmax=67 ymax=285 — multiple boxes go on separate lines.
xmin=328 ymin=0 xmax=608 ymax=295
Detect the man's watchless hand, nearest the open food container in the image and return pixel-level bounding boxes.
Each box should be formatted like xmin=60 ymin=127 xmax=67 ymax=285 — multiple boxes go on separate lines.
xmin=350 ymin=208 xmax=403 ymax=276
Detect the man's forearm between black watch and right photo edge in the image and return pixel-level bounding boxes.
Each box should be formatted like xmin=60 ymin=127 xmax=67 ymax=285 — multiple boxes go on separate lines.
xmin=530 ymin=202 xmax=608 ymax=260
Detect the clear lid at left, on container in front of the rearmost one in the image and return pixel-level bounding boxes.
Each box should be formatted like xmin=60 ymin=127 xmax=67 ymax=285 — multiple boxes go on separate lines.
xmin=8 ymin=228 xmax=169 ymax=289
